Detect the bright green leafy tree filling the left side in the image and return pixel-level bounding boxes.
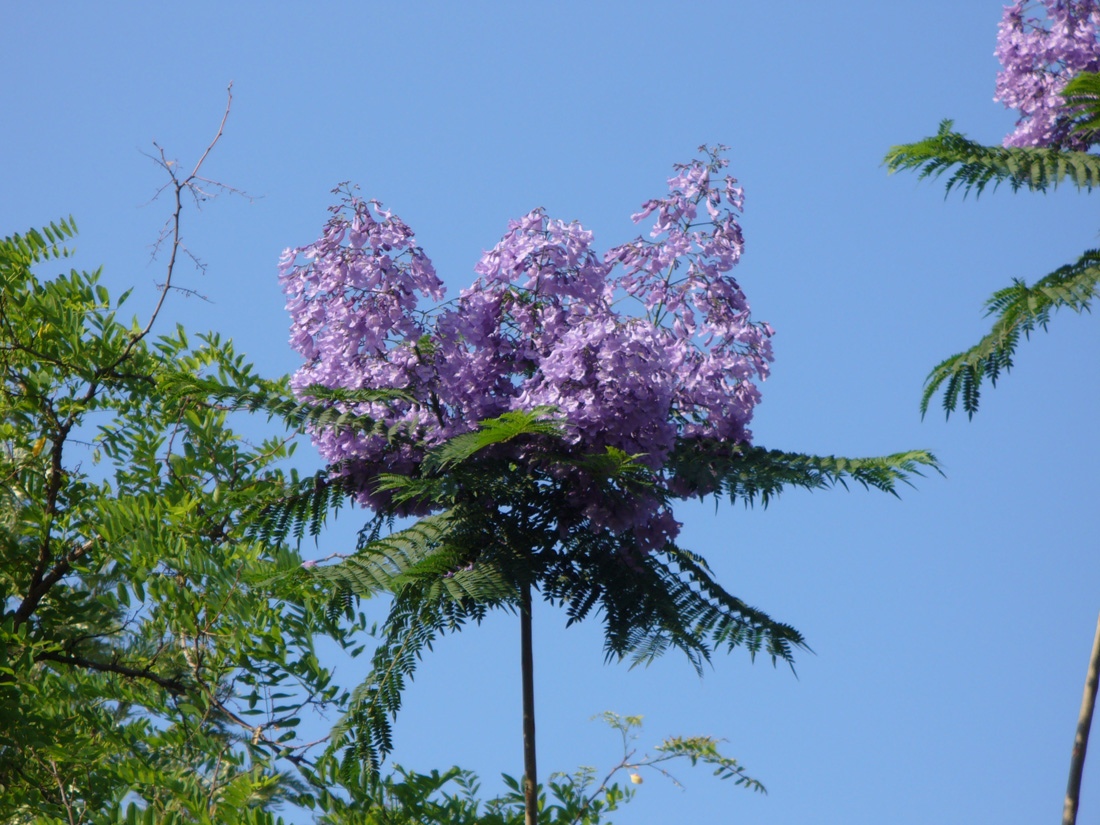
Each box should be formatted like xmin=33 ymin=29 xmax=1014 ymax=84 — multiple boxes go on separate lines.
xmin=0 ymin=221 xmax=356 ymax=823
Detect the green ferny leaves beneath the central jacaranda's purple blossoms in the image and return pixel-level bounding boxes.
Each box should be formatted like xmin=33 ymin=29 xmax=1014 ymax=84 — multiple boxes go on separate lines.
xmin=264 ymin=409 xmax=936 ymax=781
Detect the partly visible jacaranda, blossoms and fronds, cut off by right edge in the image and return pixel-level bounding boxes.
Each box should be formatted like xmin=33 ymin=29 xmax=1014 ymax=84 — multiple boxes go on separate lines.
xmin=886 ymin=0 xmax=1100 ymax=417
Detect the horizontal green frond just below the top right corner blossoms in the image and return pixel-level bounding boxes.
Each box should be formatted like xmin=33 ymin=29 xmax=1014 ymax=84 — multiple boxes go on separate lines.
xmin=884 ymin=120 xmax=1100 ymax=195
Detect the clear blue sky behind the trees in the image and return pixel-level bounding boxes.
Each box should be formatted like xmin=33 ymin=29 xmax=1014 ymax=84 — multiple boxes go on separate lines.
xmin=0 ymin=0 xmax=1100 ymax=825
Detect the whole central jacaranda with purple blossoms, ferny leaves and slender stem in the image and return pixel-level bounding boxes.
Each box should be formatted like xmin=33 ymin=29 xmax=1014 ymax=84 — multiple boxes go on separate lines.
xmin=259 ymin=147 xmax=934 ymax=823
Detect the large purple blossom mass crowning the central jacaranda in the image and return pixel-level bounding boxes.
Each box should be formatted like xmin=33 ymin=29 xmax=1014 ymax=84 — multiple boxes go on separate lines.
xmin=281 ymin=147 xmax=772 ymax=549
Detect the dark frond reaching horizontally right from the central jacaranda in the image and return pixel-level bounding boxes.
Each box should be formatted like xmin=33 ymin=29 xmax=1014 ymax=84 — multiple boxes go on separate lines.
xmin=669 ymin=440 xmax=939 ymax=506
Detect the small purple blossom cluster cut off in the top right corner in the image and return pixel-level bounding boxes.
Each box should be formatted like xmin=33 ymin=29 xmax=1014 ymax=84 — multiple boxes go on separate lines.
xmin=993 ymin=0 xmax=1100 ymax=150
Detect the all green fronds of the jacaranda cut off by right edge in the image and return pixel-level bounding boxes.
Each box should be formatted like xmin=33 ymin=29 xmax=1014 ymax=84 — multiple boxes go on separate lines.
xmin=886 ymin=89 xmax=1100 ymax=418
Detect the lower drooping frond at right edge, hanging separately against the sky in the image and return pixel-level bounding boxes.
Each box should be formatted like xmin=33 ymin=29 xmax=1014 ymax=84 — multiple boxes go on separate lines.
xmin=921 ymin=250 xmax=1100 ymax=418
